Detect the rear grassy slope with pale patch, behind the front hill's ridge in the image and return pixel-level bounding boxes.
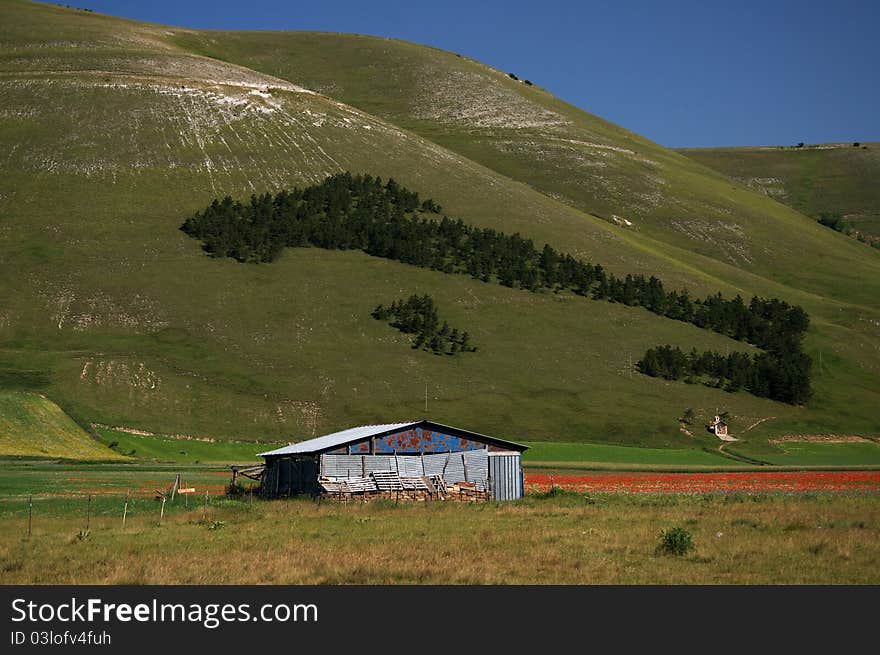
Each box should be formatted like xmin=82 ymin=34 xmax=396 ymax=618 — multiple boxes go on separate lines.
xmin=172 ymin=30 xmax=880 ymax=303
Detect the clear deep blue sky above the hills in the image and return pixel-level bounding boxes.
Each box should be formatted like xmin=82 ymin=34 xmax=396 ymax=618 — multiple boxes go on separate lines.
xmin=79 ymin=0 xmax=880 ymax=147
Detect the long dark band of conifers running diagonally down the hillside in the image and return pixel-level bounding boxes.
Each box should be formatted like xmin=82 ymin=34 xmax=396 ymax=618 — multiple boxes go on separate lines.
xmin=181 ymin=172 xmax=810 ymax=403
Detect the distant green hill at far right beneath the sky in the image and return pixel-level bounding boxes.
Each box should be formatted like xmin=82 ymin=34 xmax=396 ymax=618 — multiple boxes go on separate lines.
xmin=679 ymin=143 xmax=880 ymax=238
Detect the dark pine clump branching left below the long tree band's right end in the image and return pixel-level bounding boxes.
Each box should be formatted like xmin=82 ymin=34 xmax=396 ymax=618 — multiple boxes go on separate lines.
xmin=636 ymin=346 xmax=812 ymax=405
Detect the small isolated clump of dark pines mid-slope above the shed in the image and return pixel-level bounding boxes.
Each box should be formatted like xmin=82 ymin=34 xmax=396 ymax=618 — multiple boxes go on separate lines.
xmin=371 ymin=294 xmax=477 ymax=355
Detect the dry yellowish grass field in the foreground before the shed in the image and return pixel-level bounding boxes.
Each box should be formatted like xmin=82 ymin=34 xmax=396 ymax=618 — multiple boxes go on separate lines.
xmin=0 ymin=494 xmax=880 ymax=584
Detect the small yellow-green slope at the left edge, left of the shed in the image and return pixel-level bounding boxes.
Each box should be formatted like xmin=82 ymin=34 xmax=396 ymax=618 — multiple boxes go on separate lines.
xmin=0 ymin=390 xmax=124 ymax=460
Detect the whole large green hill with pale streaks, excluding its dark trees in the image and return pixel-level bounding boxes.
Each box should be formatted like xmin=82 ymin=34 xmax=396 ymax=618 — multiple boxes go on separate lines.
xmin=0 ymin=0 xmax=880 ymax=450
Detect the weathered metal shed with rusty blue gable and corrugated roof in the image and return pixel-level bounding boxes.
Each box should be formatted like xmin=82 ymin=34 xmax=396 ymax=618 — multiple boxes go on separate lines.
xmin=259 ymin=420 xmax=527 ymax=500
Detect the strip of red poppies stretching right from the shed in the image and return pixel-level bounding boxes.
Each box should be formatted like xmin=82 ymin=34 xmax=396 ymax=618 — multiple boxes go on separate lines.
xmin=525 ymin=471 xmax=880 ymax=494
